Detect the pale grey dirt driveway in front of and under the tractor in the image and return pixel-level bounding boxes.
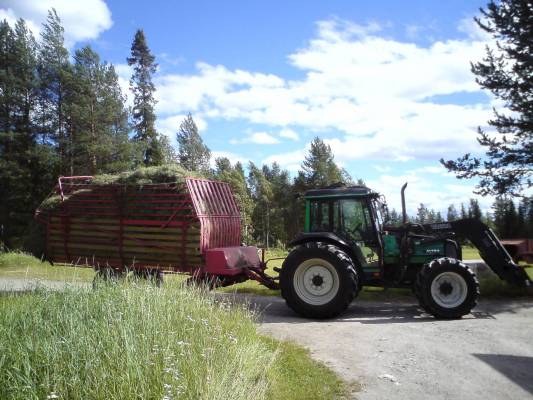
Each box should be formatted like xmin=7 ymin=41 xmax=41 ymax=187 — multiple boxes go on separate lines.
xmin=249 ymin=297 xmax=533 ymax=400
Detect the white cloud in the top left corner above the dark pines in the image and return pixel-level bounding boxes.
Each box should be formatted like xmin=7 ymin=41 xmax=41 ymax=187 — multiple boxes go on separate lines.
xmin=0 ymin=0 xmax=113 ymax=47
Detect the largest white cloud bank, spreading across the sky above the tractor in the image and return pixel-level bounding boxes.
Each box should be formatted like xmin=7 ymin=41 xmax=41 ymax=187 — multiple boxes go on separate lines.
xmin=147 ymin=19 xmax=491 ymax=162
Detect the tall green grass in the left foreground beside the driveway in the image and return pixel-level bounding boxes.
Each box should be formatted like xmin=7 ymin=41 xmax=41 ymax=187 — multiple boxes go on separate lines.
xmin=0 ymin=285 xmax=277 ymax=400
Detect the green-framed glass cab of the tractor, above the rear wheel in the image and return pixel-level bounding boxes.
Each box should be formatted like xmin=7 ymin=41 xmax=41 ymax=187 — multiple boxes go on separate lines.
xmin=302 ymin=186 xmax=383 ymax=281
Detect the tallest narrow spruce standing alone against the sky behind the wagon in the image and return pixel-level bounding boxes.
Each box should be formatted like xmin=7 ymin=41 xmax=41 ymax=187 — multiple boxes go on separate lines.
xmin=127 ymin=29 xmax=164 ymax=166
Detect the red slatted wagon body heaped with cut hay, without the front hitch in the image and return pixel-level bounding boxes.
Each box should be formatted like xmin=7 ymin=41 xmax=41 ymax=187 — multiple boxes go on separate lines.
xmin=36 ymin=166 xmax=240 ymax=270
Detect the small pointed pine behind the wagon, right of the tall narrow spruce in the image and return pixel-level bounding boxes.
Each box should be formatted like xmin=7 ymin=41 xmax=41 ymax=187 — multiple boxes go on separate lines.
xmin=176 ymin=113 xmax=211 ymax=172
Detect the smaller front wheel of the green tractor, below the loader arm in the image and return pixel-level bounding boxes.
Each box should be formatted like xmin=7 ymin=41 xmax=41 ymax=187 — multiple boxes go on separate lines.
xmin=414 ymin=257 xmax=479 ymax=319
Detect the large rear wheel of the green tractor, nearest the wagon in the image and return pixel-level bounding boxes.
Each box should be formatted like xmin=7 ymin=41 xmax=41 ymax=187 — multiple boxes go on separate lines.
xmin=280 ymin=243 xmax=359 ymax=319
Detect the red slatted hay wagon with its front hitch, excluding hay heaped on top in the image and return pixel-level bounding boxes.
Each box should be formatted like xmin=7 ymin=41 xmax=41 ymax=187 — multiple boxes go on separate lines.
xmin=35 ymin=176 xmax=278 ymax=289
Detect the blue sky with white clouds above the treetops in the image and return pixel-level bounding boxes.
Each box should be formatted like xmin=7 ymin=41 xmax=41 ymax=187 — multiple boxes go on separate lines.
xmin=0 ymin=0 xmax=501 ymax=213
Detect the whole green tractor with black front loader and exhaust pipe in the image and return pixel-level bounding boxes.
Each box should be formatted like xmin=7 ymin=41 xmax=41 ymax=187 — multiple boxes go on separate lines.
xmin=278 ymin=184 xmax=530 ymax=319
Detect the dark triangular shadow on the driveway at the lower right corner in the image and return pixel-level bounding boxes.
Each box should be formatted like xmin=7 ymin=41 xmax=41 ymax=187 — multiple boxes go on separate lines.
xmin=473 ymin=354 xmax=533 ymax=394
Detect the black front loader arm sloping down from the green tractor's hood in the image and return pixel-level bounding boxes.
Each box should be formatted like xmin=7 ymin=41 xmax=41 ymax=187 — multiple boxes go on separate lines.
xmin=424 ymin=218 xmax=531 ymax=286
